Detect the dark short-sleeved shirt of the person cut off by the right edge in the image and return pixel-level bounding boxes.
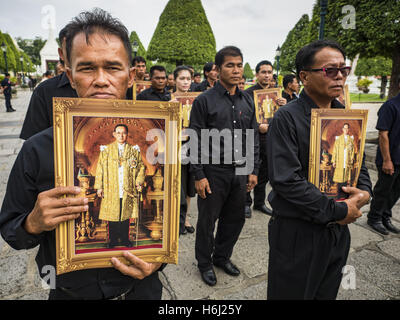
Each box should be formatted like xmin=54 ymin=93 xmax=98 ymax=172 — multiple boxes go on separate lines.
xmin=375 ymin=94 xmax=400 ymax=167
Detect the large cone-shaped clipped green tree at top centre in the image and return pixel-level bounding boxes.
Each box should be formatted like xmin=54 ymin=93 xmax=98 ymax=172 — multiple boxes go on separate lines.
xmin=147 ymin=0 xmax=216 ymax=65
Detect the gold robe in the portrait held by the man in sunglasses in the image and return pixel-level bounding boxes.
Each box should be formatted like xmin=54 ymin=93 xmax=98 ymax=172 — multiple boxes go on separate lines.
xmin=332 ymin=134 xmax=355 ymax=183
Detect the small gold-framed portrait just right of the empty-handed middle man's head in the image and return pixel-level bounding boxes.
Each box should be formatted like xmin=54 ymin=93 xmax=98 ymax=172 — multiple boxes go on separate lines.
xmin=254 ymin=87 xmax=282 ymax=123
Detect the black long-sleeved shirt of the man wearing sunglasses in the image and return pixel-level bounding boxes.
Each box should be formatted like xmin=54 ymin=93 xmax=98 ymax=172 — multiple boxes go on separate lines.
xmin=267 ymin=90 xmax=372 ymax=224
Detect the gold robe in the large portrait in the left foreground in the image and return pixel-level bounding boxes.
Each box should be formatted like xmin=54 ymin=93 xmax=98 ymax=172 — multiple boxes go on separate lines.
xmin=94 ymin=142 xmax=145 ymax=221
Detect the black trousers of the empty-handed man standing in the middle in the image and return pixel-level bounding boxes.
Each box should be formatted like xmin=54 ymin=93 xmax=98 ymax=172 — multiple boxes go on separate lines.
xmin=195 ymin=165 xmax=247 ymax=272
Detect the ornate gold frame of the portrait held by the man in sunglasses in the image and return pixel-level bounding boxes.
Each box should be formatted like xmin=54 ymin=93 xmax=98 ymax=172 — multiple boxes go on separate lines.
xmin=308 ymin=109 xmax=368 ymax=195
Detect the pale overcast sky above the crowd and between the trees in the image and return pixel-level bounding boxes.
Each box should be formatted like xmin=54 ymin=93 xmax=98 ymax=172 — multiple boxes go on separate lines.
xmin=0 ymin=0 xmax=315 ymax=69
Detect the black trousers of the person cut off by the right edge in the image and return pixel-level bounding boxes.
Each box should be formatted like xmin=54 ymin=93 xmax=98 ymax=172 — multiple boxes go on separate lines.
xmin=368 ymin=166 xmax=400 ymax=222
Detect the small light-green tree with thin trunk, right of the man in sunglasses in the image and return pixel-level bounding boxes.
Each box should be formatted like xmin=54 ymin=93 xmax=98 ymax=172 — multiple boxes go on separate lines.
xmin=354 ymin=57 xmax=392 ymax=99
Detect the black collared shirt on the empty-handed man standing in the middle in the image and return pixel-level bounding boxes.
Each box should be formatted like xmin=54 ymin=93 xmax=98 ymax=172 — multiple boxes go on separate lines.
xmin=189 ymin=81 xmax=259 ymax=180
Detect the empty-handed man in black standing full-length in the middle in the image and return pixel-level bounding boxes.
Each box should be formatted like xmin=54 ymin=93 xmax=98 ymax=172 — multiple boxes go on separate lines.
xmin=190 ymin=47 xmax=259 ymax=286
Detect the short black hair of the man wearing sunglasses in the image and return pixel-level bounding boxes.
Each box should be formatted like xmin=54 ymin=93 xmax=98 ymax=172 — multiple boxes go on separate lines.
xmin=296 ymin=40 xmax=346 ymax=77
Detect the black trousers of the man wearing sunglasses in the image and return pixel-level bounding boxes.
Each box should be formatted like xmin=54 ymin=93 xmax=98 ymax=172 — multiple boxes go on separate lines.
xmin=267 ymin=217 xmax=350 ymax=300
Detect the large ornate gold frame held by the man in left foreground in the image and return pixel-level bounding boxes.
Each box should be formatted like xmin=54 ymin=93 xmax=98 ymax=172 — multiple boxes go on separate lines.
xmin=53 ymin=98 xmax=182 ymax=274
